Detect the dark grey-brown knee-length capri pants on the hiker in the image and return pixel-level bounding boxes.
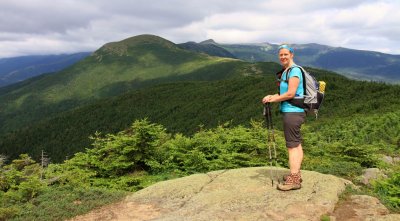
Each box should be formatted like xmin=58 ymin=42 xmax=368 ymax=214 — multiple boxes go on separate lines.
xmin=283 ymin=112 xmax=306 ymax=148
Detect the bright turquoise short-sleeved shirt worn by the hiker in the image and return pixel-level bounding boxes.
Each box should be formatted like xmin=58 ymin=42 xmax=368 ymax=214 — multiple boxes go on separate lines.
xmin=279 ymin=66 xmax=304 ymax=113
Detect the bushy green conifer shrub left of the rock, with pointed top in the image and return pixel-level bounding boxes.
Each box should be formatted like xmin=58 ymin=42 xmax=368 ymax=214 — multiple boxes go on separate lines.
xmin=86 ymin=119 xmax=168 ymax=177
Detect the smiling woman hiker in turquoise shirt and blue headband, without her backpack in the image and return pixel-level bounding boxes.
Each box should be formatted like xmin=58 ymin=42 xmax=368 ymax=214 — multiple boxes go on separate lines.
xmin=262 ymin=44 xmax=306 ymax=191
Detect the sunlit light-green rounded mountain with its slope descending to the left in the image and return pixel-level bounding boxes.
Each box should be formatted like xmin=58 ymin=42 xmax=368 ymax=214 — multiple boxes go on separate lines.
xmin=0 ymin=35 xmax=244 ymax=133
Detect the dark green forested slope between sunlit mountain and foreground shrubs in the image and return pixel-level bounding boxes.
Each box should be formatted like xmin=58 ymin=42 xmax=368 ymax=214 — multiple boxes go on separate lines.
xmin=0 ymin=63 xmax=400 ymax=161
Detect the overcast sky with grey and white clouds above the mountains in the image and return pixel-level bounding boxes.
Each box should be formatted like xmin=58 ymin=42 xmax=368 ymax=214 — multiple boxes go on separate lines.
xmin=0 ymin=0 xmax=400 ymax=58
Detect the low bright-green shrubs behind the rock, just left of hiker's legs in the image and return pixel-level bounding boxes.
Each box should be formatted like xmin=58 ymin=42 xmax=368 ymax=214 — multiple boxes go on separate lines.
xmin=164 ymin=122 xmax=287 ymax=174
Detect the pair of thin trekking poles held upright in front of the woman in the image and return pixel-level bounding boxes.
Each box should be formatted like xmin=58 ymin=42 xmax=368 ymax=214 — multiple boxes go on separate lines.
xmin=264 ymin=102 xmax=279 ymax=186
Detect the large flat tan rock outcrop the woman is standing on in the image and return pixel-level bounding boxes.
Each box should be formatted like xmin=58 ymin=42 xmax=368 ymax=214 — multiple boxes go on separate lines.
xmin=73 ymin=167 xmax=398 ymax=221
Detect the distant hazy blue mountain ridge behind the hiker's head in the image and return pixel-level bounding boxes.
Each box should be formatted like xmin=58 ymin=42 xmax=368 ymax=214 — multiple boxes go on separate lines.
xmin=219 ymin=43 xmax=400 ymax=83
